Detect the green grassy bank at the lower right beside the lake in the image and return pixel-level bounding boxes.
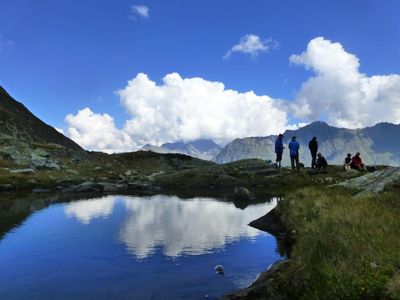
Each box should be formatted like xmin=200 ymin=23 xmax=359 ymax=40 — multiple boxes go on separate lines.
xmin=279 ymin=188 xmax=400 ymax=299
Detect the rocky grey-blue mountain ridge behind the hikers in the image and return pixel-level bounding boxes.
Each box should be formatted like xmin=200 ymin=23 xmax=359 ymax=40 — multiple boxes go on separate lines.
xmin=215 ymin=122 xmax=400 ymax=166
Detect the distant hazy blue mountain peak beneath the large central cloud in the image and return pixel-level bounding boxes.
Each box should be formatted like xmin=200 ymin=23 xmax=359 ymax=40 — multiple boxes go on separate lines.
xmin=142 ymin=139 xmax=222 ymax=160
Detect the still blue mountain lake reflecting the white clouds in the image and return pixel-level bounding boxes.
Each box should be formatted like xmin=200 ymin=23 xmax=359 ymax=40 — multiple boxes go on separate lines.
xmin=0 ymin=195 xmax=280 ymax=299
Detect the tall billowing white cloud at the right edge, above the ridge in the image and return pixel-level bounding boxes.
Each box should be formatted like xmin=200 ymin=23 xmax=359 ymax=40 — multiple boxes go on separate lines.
xmin=290 ymin=37 xmax=400 ymax=128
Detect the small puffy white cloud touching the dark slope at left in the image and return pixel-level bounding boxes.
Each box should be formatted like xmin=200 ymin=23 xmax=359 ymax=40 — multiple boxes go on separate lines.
xmin=65 ymin=108 xmax=135 ymax=153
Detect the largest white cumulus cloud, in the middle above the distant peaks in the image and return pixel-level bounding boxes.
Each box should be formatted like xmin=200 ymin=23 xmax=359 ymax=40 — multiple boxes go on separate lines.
xmin=118 ymin=73 xmax=287 ymax=145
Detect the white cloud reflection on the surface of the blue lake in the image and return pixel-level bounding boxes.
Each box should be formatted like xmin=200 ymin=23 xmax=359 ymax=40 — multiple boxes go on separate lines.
xmin=65 ymin=195 xmax=276 ymax=258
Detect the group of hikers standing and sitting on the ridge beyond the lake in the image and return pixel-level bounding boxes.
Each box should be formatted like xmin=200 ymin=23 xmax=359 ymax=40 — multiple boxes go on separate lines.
xmin=275 ymin=134 xmax=368 ymax=172
